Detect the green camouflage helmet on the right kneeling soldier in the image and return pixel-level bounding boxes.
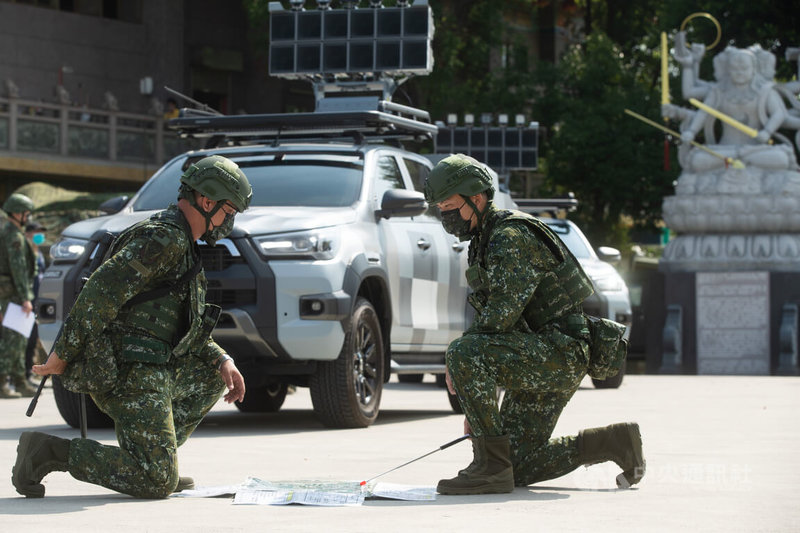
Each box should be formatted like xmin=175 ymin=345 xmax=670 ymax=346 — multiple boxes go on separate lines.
xmin=425 ymin=154 xmax=494 ymax=205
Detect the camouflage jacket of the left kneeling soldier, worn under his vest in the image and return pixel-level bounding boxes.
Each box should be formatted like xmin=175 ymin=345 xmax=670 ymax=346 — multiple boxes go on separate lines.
xmin=54 ymin=205 xmax=224 ymax=364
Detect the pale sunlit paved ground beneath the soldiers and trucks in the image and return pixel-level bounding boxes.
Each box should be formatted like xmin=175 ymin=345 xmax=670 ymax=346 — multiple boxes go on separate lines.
xmin=0 ymin=375 xmax=800 ymax=533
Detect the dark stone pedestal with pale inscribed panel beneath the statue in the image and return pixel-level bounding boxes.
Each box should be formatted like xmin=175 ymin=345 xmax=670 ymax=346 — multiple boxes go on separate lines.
xmin=659 ymin=270 xmax=800 ymax=375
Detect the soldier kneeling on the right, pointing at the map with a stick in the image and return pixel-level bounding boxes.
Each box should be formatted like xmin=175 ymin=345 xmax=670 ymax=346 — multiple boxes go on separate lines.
xmin=425 ymin=154 xmax=645 ymax=494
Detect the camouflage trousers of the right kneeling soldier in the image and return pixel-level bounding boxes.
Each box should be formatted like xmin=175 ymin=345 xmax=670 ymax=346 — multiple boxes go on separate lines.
xmin=447 ymin=328 xmax=589 ymax=486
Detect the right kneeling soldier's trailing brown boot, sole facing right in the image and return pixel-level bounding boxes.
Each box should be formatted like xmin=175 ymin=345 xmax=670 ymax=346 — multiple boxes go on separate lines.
xmin=578 ymin=422 xmax=646 ymax=489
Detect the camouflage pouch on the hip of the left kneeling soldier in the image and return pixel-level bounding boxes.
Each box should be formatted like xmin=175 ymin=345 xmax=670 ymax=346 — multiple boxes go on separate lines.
xmin=60 ymin=331 xmax=118 ymax=394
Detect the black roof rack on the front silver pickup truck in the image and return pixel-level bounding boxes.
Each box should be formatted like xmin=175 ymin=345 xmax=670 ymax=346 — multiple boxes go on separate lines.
xmin=168 ymin=97 xmax=438 ymax=144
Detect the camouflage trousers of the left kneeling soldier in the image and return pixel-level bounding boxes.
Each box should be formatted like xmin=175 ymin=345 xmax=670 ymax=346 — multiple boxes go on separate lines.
xmin=69 ymin=355 xmax=225 ymax=498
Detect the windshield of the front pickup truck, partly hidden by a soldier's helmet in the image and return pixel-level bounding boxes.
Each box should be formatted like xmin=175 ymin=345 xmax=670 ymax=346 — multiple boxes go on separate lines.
xmin=133 ymin=158 xmax=364 ymax=211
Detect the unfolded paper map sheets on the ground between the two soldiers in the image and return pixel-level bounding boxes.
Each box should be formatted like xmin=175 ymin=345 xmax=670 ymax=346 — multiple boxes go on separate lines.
xmin=174 ymin=477 xmax=436 ymax=506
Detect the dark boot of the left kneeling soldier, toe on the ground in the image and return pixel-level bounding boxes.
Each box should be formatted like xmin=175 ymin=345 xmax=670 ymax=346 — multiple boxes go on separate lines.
xmin=11 ymin=431 xmax=70 ymax=498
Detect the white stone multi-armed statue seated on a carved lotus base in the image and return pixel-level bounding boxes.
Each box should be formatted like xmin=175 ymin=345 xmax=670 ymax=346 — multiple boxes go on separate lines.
xmin=661 ymin=32 xmax=800 ymax=271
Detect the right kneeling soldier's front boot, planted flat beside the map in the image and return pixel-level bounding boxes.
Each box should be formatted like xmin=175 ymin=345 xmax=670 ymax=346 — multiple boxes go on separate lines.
xmin=436 ymin=435 xmax=514 ymax=494
